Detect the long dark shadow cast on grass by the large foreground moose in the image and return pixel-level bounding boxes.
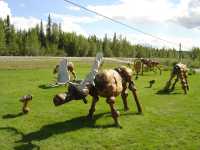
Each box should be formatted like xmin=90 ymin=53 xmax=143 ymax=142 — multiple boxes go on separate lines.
xmin=0 ymin=112 xmax=141 ymax=150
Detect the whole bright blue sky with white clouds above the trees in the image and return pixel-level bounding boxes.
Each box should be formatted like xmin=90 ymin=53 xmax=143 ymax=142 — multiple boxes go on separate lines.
xmin=0 ymin=0 xmax=200 ymax=50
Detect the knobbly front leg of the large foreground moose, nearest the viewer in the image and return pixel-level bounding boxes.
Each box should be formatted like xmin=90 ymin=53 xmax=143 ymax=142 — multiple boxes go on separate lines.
xmin=106 ymin=96 xmax=121 ymax=128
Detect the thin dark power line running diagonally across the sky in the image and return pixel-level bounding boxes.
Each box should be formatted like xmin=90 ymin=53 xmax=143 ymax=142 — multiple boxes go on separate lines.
xmin=64 ymin=0 xmax=188 ymax=50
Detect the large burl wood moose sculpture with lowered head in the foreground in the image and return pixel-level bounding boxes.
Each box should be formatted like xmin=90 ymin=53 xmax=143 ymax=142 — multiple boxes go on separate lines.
xmin=53 ymin=53 xmax=142 ymax=127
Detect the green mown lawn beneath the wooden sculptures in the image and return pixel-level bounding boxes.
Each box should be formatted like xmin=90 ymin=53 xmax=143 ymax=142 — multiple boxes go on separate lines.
xmin=0 ymin=58 xmax=200 ymax=150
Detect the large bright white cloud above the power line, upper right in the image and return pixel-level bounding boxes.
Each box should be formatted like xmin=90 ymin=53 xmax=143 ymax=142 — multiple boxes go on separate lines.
xmin=88 ymin=0 xmax=200 ymax=28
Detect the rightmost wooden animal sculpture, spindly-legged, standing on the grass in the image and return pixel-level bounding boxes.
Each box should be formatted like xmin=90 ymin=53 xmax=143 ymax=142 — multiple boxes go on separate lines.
xmin=164 ymin=63 xmax=189 ymax=94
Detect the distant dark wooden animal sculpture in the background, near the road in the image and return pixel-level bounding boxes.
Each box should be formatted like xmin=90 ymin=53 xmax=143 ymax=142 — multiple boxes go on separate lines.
xmin=140 ymin=58 xmax=162 ymax=75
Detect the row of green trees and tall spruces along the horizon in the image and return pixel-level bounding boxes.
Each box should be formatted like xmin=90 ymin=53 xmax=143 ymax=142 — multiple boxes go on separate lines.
xmin=0 ymin=15 xmax=200 ymax=60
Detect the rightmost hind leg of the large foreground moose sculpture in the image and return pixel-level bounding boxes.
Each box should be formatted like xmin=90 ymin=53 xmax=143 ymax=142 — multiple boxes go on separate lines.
xmin=128 ymin=81 xmax=142 ymax=114
